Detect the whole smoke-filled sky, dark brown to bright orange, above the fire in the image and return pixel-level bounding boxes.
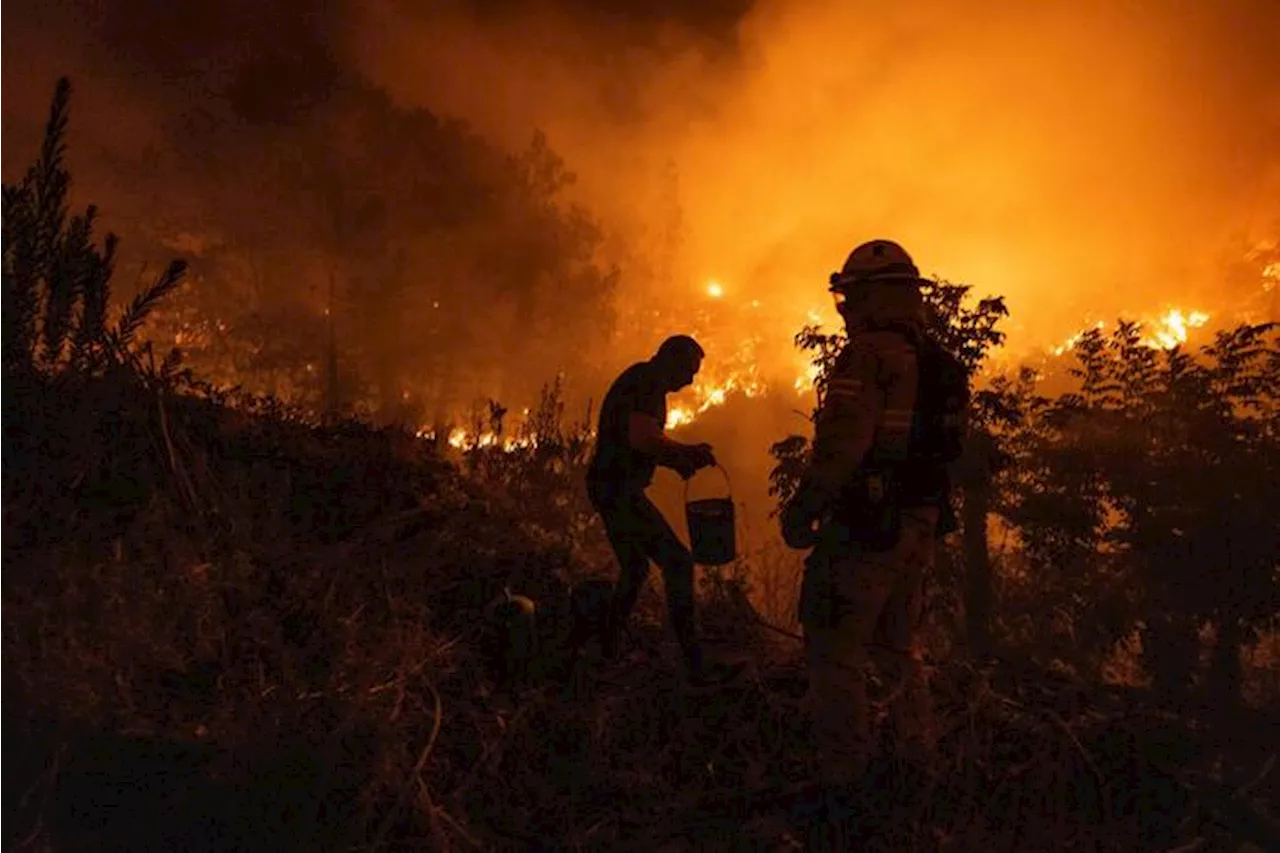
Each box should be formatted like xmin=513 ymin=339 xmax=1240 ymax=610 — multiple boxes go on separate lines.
xmin=0 ymin=0 xmax=1280 ymax=391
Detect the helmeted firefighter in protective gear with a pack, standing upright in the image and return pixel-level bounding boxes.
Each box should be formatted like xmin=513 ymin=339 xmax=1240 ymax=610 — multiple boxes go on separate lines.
xmin=782 ymin=240 xmax=968 ymax=788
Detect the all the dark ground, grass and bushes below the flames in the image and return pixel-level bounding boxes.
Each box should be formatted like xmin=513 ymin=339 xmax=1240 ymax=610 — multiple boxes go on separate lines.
xmin=0 ymin=81 xmax=1280 ymax=853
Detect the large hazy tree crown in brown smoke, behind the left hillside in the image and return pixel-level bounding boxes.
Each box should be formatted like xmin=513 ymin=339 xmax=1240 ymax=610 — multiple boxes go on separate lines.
xmin=142 ymin=81 xmax=618 ymax=427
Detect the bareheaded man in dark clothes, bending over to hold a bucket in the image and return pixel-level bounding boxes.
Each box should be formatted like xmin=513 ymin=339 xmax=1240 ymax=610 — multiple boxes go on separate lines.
xmin=586 ymin=334 xmax=747 ymax=684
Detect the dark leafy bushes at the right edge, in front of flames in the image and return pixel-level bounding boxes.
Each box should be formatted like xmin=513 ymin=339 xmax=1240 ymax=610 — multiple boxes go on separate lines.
xmin=1002 ymin=323 xmax=1280 ymax=701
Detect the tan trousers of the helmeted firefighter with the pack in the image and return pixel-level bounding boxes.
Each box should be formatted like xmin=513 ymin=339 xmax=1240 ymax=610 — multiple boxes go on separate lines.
xmin=800 ymin=507 xmax=938 ymax=785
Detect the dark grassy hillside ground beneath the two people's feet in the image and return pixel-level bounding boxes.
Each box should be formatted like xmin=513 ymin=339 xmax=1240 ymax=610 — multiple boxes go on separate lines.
xmin=0 ymin=373 xmax=1277 ymax=852
